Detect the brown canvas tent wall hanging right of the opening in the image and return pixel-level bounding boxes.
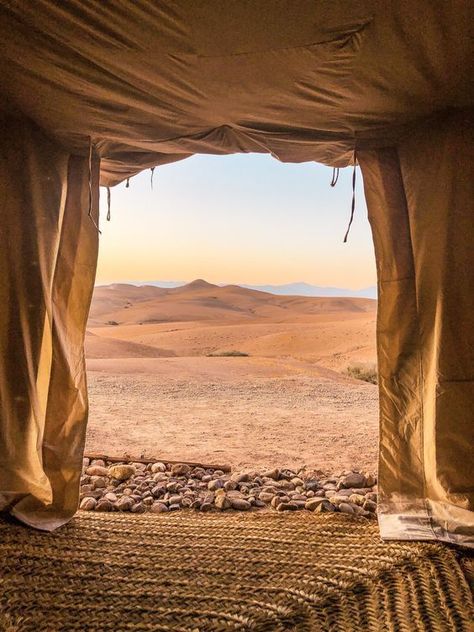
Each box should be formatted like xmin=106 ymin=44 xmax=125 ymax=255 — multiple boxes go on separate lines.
xmin=358 ymin=111 xmax=474 ymax=546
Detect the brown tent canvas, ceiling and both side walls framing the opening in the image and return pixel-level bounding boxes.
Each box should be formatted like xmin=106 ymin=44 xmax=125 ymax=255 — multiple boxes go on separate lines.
xmin=0 ymin=0 xmax=474 ymax=546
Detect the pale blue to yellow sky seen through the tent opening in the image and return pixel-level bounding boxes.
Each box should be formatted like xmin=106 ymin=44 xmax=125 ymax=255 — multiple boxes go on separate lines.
xmin=97 ymin=154 xmax=376 ymax=289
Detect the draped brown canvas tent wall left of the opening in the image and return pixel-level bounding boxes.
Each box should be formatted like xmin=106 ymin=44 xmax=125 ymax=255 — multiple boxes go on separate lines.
xmin=0 ymin=118 xmax=99 ymax=529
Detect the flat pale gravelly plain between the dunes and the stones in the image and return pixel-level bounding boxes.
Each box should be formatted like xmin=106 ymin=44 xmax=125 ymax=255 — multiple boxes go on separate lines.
xmin=86 ymin=358 xmax=378 ymax=472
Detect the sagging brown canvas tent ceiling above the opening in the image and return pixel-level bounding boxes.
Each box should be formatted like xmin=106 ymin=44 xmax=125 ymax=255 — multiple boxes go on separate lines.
xmin=0 ymin=0 xmax=472 ymax=186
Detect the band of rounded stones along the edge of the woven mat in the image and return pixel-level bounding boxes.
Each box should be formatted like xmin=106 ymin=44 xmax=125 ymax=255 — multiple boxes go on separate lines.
xmin=80 ymin=458 xmax=377 ymax=518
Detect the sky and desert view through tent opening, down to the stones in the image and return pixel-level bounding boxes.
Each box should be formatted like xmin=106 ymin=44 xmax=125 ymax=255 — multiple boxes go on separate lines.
xmin=86 ymin=154 xmax=378 ymax=488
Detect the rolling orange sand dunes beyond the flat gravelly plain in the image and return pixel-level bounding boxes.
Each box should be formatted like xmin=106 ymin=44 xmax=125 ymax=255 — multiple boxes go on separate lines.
xmin=87 ymin=280 xmax=376 ymax=368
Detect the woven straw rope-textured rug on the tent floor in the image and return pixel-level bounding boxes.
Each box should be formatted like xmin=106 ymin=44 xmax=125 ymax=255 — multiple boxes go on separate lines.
xmin=0 ymin=511 xmax=474 ymax=632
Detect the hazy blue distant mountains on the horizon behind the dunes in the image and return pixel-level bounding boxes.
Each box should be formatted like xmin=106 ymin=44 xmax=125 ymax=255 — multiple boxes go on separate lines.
xmin=109 ymin=281 xmax=377 ymax=299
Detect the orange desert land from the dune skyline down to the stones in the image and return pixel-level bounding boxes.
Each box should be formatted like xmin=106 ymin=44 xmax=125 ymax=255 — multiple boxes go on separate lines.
xmin=86 ymin=280 xmax=378 ymax=472
